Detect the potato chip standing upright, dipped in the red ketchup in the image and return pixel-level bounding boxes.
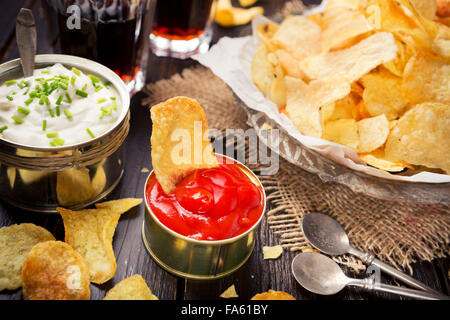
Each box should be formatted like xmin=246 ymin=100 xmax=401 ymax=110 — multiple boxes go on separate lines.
xmin=150 ymin=97 xmax=218 ymax=193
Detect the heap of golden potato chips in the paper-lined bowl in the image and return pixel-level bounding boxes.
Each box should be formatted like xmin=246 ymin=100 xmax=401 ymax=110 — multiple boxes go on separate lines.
xmin=252 ymin=0 xmax=450 ymax=174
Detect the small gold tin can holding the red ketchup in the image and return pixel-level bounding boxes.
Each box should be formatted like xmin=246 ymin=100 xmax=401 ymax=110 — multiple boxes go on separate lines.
xmin=142 ymin=154 xmax=266 ymax=280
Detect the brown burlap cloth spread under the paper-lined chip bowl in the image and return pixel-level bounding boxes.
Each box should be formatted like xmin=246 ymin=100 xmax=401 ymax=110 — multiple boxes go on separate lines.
xmin=143 ymin=66 xmax=450 ymax=271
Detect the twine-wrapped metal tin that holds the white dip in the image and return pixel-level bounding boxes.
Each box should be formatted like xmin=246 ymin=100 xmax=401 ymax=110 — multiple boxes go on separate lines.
xmin=0 ymin=54 xmax=130 ymax=213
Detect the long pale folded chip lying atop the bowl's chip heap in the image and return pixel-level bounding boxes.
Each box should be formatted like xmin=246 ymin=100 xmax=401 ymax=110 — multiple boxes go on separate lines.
xmin=300 ymin=32 xmax=397 ymax=82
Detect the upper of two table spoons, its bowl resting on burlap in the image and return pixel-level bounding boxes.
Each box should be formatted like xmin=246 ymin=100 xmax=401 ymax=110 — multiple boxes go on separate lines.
xmin=302 ymin=212 xmax=440 ymax=295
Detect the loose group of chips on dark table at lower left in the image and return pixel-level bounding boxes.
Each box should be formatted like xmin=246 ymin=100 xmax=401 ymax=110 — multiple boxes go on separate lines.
xmin=0 ymin=198 xmax=157 ymax=300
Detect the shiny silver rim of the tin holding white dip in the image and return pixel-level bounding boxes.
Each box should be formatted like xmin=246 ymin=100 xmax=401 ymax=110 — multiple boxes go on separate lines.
xmin=0 ymin=54 xmax=130 ymax=152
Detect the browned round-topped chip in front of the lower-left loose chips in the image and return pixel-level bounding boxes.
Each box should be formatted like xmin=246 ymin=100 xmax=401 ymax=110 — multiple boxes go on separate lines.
xmin=22 ymin=241 xmax=91 ymax=300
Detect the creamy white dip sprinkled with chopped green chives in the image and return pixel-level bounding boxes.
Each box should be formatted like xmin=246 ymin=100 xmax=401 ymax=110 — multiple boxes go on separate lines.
xmin=0 ymin=63 xmax=122 ymax=147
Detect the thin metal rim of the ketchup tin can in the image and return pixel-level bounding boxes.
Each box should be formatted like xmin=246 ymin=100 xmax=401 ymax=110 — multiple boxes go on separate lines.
xmin=144 ymin=153 xmax=267 ymax=245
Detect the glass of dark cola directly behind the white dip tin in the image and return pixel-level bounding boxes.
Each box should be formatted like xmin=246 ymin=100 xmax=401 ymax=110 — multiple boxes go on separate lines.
xmin=43 ymin=0 xmax=156 ymax=94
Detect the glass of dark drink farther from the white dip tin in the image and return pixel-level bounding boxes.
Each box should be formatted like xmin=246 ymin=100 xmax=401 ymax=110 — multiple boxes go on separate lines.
xmin=150 ymin=0 xmax=215 ymax=59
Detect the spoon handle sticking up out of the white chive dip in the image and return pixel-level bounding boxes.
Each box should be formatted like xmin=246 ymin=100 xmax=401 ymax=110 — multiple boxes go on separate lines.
xmin=16 ymin=8 xmax=36 ymax=77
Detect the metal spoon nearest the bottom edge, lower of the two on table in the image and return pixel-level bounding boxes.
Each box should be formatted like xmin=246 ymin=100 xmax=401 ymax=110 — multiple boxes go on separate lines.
xmin=292 ymin=252 xmax=450 ymax=300
